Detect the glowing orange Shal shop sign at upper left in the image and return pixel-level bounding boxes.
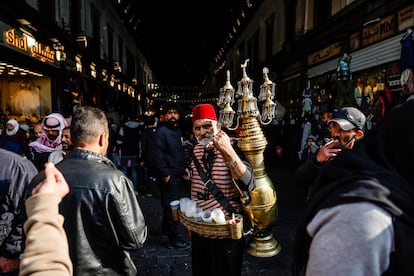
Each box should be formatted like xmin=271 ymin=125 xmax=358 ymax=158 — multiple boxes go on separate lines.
xmin=3 ymin=28 xmax=56 ymax=64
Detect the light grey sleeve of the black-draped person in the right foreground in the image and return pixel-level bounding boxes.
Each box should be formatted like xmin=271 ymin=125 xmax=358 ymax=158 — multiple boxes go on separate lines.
xmin=306 ymin=202 xmax=394 ymax=276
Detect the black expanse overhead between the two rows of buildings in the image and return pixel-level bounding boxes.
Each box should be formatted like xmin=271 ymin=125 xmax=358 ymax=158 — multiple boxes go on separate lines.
xmin=131 ymin=0 xmax=243 ymax=86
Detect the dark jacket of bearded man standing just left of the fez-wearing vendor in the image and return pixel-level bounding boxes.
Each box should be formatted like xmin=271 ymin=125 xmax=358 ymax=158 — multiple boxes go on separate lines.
xmin=155 ymin=123 xmax=186 ymax=177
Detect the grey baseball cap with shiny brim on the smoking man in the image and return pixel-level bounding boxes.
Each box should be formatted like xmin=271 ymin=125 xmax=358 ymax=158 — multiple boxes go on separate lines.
xmin=328 ymin=107 xmax=366 ymax=130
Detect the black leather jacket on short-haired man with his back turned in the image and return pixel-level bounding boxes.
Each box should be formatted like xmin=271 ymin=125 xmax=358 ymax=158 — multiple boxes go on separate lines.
xmin=31 ymin=149 xmax=147 ymax=275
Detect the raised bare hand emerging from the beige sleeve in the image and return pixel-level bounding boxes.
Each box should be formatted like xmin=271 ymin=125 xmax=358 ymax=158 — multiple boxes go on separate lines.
xmin=32 ymin=162 xmax=69 ymax=199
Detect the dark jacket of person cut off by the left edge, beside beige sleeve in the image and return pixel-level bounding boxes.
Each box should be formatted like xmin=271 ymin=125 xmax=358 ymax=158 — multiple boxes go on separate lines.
xmin=0 ymin=149 xmax=37 ymax=259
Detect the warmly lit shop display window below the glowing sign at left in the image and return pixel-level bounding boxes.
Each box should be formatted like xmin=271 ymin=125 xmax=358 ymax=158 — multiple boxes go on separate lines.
xmin=0 ymin=61 xmax=52 ymax=123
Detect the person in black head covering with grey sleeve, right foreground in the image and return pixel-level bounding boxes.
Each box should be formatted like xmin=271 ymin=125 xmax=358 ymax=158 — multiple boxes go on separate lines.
xmin=293 ymin=76 xmax=414 ymax=276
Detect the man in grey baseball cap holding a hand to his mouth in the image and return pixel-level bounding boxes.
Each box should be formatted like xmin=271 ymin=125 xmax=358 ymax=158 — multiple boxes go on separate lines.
xmin=296 ymin=107 xmax=366 ymax=201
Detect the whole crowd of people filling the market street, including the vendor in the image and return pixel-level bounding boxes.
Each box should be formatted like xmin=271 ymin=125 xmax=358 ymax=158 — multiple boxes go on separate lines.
xmin=0 ymin=69 xmax=414 ymax=276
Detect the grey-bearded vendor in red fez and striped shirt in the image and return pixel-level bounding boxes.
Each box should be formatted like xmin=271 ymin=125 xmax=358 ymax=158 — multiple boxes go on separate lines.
xmin=191 ymin=104 xmax=254 ymax=276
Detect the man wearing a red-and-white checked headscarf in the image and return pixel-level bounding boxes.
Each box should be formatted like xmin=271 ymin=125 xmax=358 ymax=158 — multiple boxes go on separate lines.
xmin=29 ymin=113 xmax=68 ymax=171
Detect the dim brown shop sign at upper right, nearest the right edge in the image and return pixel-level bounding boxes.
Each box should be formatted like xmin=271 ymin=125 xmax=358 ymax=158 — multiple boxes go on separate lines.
xmin=362 ymin=15 xmax=396 ymax=46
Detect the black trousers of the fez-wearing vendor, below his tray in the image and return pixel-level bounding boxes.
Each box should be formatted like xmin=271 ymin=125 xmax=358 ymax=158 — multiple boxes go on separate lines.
xmin=191 ymin=232 xmax=245 ymax=276
